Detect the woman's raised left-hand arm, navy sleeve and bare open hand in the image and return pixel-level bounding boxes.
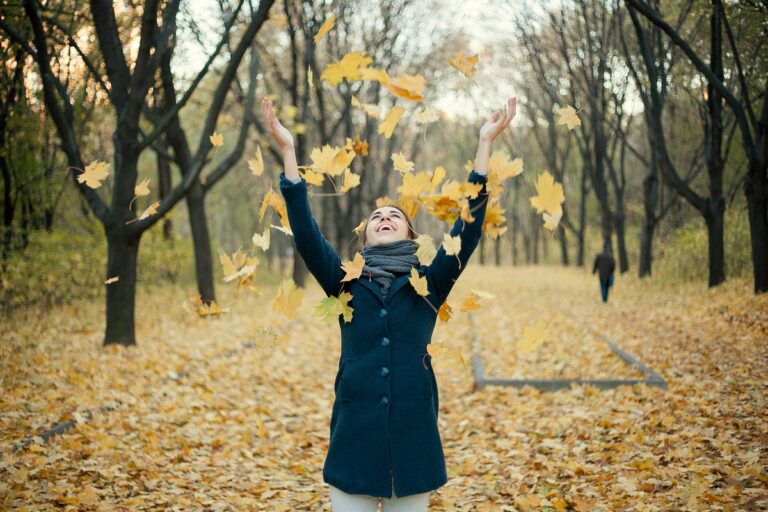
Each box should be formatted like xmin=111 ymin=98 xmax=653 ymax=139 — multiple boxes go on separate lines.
xmin=261 ymin=99 xmax=344 ymax=296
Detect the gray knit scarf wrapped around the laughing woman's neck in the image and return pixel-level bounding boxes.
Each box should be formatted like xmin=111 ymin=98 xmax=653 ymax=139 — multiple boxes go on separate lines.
xmin=360 ymin=239 xmax=419 ymax=297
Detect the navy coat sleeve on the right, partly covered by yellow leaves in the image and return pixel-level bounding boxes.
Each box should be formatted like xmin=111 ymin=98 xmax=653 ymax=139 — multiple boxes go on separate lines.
xmin=425 ymin=170 xmax=489 ymax=307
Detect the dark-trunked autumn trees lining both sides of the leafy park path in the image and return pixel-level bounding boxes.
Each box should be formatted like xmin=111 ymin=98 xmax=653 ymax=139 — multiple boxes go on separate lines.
xmin=0 ymin=0 xmax=768 ymax=344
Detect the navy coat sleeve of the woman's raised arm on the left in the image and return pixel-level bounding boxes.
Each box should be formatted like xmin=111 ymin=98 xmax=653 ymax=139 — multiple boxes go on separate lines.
xmin=280 ymin=172 xmax=344 ymax=296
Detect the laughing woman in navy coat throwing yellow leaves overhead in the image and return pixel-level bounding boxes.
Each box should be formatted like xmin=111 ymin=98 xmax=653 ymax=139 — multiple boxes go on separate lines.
xmin=262 ymin=97 xmax=517 ymax=512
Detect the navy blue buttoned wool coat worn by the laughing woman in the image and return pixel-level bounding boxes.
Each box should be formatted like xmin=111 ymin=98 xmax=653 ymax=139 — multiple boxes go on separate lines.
xmin=280 ymin=170 xmax=488 ymax=498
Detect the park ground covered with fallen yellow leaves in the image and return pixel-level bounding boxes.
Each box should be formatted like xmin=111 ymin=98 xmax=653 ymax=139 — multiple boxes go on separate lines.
xmin=0 ymin=264 xmax=768 ymax=512
